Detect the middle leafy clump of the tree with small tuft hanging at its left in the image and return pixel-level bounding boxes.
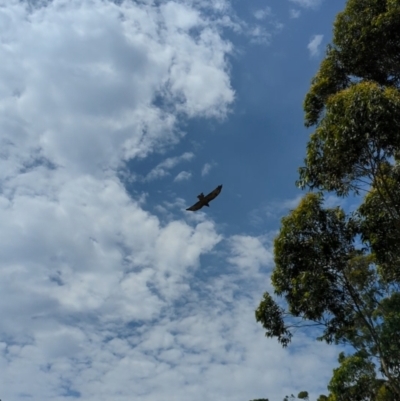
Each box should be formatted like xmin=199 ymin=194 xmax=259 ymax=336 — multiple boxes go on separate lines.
xmin=256 ymin=194 xmax=368 ymax=345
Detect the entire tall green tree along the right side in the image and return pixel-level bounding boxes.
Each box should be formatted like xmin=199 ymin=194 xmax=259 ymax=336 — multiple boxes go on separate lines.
xmin=256 ymin=0 xmax=400 ymax=401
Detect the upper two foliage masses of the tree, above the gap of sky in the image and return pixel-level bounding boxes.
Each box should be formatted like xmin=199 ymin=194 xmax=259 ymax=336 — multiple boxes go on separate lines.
xmin=298 ymin=0 xmax=400 ymax=196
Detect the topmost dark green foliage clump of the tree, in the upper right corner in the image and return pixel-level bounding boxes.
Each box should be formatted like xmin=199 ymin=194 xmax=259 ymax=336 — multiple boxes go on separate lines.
xmin=304 ymin=0 xmax=400 ymax=126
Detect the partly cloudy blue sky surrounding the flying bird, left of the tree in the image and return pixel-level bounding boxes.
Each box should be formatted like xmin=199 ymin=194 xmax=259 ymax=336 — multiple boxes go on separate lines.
xmin=0 ymin=0 xmax=352 ymax=401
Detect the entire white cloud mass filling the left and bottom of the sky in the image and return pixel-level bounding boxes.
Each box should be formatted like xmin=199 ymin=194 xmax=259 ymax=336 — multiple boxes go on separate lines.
xmin=0 ymin=0 xmax=344 ymax=401
